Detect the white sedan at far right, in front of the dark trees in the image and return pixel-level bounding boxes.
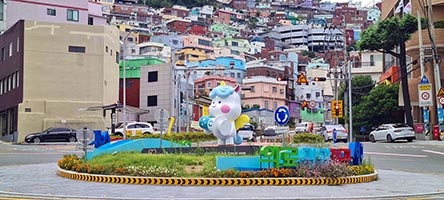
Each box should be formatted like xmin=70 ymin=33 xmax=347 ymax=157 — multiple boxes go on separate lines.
xmin=369 ymin=123 xmax=416 ymax=142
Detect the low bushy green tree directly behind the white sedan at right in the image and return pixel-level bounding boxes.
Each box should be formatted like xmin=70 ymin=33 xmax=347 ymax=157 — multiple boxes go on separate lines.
xmin=352 ymin=84 xmax=404 ymax=134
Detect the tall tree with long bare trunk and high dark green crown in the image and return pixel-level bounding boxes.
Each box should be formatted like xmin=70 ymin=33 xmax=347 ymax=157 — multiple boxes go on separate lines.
xmin=358 ymin=15 xmax=418 ymax=127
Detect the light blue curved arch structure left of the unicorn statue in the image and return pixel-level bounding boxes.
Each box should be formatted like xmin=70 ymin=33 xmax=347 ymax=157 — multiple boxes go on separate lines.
xmin=86 ymin=138 xmax=187 ymax=160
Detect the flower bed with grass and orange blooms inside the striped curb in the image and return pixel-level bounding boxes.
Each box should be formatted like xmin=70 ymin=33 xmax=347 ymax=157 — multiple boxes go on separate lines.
xmin=58 ymin=153 xmax=374 ymax=178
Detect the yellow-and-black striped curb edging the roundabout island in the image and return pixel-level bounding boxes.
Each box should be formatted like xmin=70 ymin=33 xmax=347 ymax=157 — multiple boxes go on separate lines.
xmin=57 ymin=167 xmax=378 ymax=186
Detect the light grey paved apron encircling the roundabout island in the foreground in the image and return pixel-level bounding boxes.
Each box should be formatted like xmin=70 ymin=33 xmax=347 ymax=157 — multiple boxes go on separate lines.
xmin=0 ymin=163 xmax=444 ymax=200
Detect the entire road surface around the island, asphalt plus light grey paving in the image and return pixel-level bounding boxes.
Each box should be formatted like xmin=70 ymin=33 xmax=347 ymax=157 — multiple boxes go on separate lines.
xmin=0 ymin=141 xmax=444 ymax=200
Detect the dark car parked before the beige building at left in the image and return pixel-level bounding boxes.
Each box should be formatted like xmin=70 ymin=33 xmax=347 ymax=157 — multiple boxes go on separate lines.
xmin=25 ymin=127 xmax=77 ymax=144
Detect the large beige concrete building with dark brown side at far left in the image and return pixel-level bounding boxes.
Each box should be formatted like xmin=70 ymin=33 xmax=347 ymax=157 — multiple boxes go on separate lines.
xmin=0 ymin=20 xmax=119 ymax=142
